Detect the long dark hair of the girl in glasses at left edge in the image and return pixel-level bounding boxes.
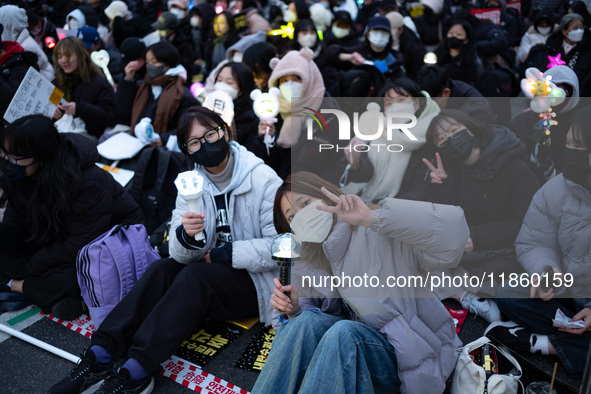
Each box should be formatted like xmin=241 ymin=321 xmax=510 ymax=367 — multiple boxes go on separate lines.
xmin=0 ymin=115 xmax=83 ymax=245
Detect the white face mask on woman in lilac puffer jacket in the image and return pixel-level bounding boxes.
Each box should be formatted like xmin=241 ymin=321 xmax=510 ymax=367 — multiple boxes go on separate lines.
xmin=290 ymin=200 xmax=333 ymax=244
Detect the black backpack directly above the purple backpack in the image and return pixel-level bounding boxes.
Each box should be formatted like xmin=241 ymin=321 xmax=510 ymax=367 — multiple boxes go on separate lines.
xmin=131 ymin=147 xmax=189 ymax=234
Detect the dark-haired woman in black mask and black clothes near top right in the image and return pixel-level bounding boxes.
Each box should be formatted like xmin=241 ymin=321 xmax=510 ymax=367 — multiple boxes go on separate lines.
xmin=435 ymin=21 xmax=482 ymax=85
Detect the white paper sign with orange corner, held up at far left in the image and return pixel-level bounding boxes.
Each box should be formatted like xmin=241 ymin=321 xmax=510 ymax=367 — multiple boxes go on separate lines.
xmin=4 ymin=67 xmax=64 ymax=123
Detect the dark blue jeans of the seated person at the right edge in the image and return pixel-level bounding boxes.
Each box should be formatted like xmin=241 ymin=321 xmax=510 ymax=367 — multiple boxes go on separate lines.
xmin=495 ymin=282 xmax=591 ymax=376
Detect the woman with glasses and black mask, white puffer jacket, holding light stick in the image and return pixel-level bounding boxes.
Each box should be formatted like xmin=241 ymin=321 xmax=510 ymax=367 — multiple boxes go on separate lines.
xmin=51 ymin=107 xmax=281 ymax=393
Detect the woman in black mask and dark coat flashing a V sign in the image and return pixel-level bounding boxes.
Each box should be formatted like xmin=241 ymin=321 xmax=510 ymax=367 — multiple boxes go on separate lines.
xmin=412 ymin=110 xmax=540 ymax=322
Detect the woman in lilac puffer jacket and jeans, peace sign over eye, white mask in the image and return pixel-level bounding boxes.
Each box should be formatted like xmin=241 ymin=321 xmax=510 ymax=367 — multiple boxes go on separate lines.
xmin=252 ymin=173 xmax=468 ymax=394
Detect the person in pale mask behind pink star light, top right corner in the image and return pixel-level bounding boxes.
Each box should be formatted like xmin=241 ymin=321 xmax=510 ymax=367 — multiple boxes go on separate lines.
xmin=525 ymin=14 xmax=591 ymax=86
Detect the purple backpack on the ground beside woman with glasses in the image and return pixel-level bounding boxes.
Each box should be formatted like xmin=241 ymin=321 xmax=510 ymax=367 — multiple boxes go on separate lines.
xmin=76 ymin=224 xmax=160 ymax=328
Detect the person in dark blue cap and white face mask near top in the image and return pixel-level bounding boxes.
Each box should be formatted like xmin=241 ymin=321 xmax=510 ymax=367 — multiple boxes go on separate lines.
xmin=326 ymin=16 xmax=405 ymax=80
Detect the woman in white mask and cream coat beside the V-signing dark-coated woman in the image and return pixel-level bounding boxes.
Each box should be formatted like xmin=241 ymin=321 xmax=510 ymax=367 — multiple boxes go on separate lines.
xmin=360 ymin=78 xmax=440 ymax=204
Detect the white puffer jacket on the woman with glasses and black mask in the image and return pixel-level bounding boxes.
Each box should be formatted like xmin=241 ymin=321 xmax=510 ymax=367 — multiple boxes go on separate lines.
xmin=169 ymin=141 xmax=282 ymax=324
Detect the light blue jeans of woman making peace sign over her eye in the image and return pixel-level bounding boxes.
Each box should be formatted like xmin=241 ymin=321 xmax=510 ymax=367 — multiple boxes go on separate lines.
xmin=252 ymin=311 xmax=401 ymax=394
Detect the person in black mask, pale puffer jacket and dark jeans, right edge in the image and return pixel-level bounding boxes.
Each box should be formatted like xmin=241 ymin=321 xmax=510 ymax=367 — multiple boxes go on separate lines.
xmin=491 ymin=107 xmax=591 ymax=376
